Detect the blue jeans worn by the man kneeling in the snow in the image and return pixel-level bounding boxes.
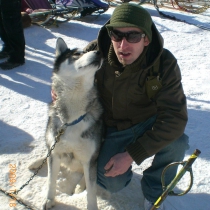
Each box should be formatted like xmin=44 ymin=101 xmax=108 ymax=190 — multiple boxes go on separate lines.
xmin=97 ymin=116 xmax=189 ymax=202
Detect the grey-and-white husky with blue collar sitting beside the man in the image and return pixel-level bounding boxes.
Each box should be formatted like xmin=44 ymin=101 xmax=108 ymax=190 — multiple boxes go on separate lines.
xmin=43 ymin=38 xmax=103 ymax=210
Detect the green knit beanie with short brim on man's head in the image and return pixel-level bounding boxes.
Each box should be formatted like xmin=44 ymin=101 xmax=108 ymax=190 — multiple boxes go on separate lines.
xmin=106 ymin=3 xmax=152 ymax=42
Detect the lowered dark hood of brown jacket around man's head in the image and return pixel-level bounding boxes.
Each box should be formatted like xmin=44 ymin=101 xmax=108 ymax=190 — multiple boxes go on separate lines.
xmin=98 ymin=20 xmax=164 ymax=67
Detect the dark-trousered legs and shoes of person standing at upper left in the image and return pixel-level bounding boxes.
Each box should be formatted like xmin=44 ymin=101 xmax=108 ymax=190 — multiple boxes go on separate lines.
xmin=0 ymin=0 xmax=25 ymax=70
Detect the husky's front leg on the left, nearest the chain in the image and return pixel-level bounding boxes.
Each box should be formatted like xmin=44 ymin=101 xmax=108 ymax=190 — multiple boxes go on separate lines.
xmin=43 ymin=153 xmax=60 ymax=210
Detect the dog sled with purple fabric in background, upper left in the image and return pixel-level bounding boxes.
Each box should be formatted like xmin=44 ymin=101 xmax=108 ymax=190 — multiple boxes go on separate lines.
xmin=22 ymin=0 xmax=109 ymax=27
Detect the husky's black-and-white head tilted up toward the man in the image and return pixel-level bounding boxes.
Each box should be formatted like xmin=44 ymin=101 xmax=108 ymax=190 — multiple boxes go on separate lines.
xmin=54 ymin=38 xmax=102 ymax=77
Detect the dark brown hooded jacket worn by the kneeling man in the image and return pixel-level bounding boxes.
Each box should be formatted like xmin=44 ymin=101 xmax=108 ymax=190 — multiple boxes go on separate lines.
xmin=86 ymin=21 xmax=187 ymax=164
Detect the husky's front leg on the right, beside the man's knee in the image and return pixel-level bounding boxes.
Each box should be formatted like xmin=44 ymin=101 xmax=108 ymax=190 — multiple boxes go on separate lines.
xmin=83 ymin=163 xmax=98 ymax=210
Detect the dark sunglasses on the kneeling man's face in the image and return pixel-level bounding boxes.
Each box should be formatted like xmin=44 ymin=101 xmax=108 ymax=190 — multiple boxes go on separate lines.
xmin=109 ymin=30 xmax=145 ymax=43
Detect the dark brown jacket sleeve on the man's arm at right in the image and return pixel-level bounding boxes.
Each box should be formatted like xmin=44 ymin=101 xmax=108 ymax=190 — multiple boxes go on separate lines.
xmin=126 ymin=50 xmax=188 ymax=165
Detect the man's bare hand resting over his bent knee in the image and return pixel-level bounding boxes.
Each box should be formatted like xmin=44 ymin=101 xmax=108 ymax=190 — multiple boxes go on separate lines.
xmin=104 ymin=152 xmax=133 ymax=177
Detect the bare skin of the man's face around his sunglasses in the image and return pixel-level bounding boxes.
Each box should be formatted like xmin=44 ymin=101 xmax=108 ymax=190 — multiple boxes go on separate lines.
xmin=112 ymin=27 xmax=149 ymax=65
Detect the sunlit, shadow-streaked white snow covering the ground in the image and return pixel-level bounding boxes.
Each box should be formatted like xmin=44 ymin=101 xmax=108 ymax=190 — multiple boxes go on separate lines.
xmin=0 ymin=4 xmax=210 ymax=210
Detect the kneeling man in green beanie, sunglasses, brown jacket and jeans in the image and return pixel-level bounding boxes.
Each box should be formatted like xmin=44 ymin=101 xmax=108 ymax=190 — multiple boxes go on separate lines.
xmin=52 ymin=3 xmax=188 ymax=210
